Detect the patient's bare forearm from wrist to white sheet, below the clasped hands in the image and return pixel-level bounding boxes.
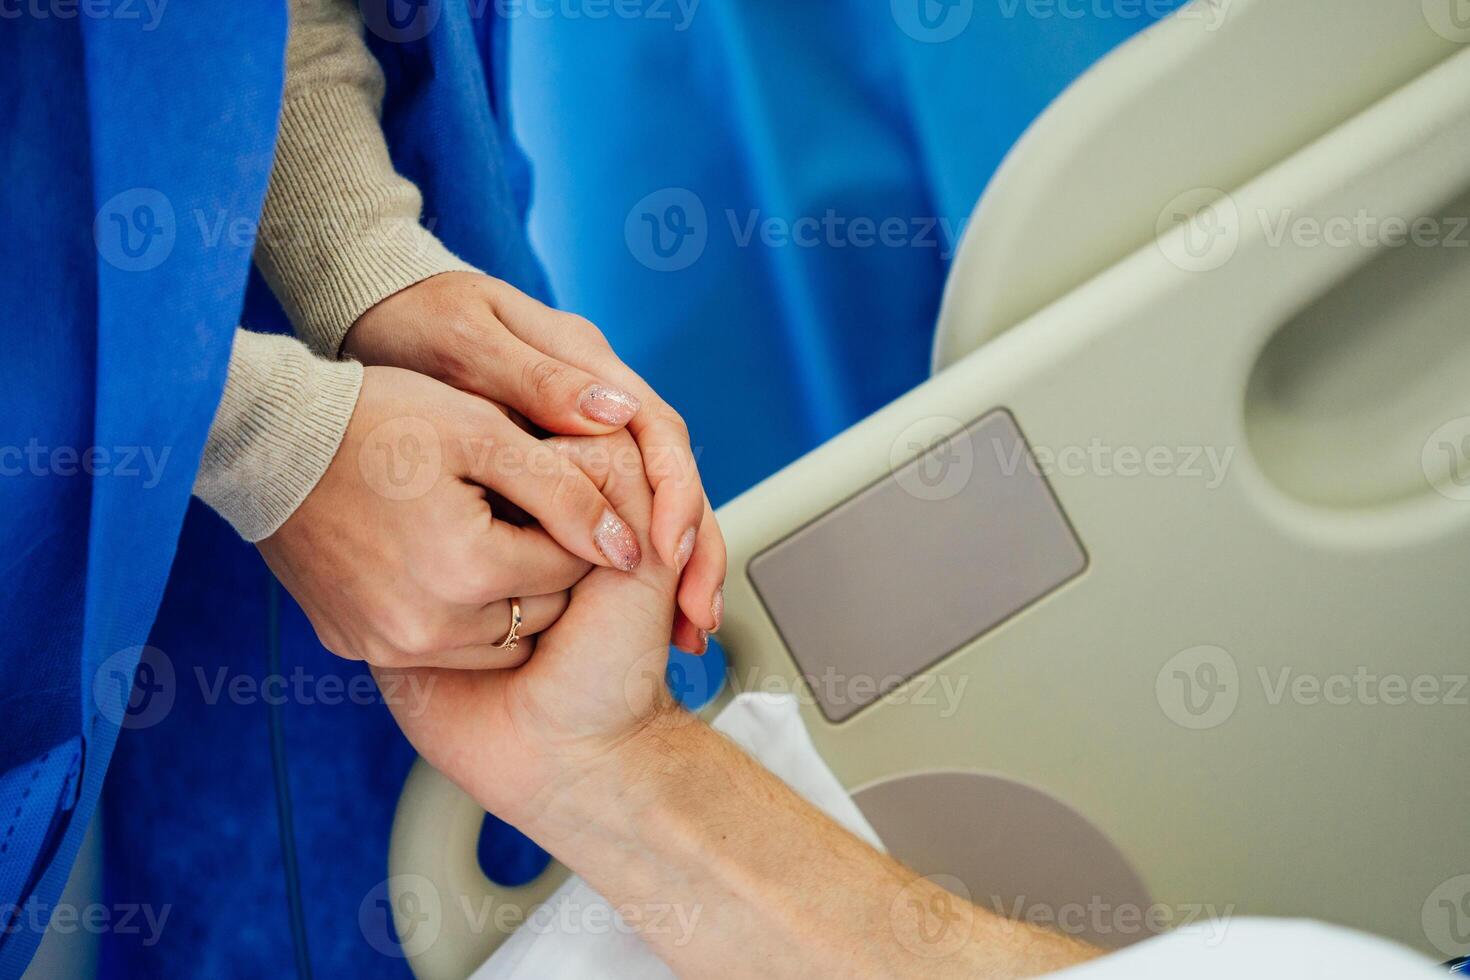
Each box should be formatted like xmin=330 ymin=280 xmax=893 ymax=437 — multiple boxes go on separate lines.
xmin=523 ymin=720 xmax=1098 ymax=977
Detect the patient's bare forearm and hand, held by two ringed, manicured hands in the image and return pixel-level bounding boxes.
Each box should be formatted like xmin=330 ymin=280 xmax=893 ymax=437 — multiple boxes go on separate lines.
xmin=375 ymin=433 xmax=1098 ymax=977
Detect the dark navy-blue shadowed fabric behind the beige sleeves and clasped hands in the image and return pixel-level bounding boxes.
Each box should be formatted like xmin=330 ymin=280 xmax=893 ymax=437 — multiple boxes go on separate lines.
xmin=103 ymin=0 xmax=548 ymax=979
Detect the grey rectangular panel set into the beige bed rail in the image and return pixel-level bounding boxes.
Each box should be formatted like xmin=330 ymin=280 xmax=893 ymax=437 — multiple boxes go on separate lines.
xmin=750 ymin=410 xmax=1088 ymax=721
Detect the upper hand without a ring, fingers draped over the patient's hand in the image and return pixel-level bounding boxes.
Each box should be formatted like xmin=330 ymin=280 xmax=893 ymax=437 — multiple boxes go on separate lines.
xmin=343 ymin=272 xmax=725 ymax=652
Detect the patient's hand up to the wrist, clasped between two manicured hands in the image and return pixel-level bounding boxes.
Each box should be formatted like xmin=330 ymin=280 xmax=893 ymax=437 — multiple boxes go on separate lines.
xmin=375 ymin=432 xmax=692 ymax=826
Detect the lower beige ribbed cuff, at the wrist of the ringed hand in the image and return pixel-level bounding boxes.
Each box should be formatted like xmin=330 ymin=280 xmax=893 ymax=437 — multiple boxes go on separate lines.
xmin=194 ymin=331 xmax=363 ymax=541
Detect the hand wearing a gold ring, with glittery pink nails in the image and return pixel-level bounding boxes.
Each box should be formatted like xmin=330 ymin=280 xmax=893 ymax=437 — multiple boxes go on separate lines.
xmin=259 ymin=367 xmax=641 ymax=667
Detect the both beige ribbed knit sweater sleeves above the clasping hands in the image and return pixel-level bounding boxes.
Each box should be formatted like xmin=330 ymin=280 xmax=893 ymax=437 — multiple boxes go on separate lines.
xmin=194 ymin=0 xmax=472 ymax=541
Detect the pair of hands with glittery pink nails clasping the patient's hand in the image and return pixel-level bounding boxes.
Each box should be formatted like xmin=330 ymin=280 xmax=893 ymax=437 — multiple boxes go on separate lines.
xmin=260 ymin=273 xmax=725 ymax=669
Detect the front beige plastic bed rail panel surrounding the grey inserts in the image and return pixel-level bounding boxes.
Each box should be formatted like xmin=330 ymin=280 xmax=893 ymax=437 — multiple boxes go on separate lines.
xmin=720 ymin=30 xmax=1470 ymax=956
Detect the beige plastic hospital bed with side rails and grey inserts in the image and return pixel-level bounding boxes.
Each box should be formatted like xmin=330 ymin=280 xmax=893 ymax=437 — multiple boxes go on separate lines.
xmin=390 ymin=0 xmax=1470 ymax=979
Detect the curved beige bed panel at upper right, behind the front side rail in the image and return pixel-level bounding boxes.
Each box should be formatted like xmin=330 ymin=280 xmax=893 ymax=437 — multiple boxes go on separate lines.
xmin=933 ymin=0 xmax=1470 ymax=372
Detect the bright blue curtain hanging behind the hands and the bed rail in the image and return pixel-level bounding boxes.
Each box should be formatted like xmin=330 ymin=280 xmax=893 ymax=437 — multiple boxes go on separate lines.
xmin=510 ymin=0 xmax=1182 ymax=504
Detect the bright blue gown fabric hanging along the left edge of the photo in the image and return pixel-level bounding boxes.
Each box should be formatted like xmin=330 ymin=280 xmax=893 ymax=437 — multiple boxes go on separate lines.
xmin=0 ymin=3 xmax=285 ymax=976
